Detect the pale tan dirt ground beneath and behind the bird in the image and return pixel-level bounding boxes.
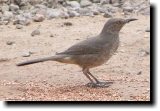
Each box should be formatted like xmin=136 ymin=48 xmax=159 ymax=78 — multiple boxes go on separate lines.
xmin=0 ymin=15 xmax=150 ymax=101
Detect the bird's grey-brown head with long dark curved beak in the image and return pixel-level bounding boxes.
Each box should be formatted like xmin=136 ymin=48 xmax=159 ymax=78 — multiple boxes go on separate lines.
xmin=101 ymin=18 xmax=137 ymax=33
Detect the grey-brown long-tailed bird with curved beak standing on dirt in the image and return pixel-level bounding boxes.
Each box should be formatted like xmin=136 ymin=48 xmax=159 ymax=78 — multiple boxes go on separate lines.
xmin=16 ymin=18 xmax=138 ymax=87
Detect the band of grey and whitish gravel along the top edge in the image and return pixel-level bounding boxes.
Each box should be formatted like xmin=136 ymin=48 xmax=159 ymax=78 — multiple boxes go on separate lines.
xmin=0 ymin=0 xmax=150 ymax=25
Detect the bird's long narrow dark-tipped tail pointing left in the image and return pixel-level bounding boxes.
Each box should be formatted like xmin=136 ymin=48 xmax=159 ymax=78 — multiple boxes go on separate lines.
xmin=16 ymin=56 xmax=62 ymax=66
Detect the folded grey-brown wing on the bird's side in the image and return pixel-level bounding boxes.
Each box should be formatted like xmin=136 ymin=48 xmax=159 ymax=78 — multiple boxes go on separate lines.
xmin=57 ymin=40 xmax=110 ymax=55
